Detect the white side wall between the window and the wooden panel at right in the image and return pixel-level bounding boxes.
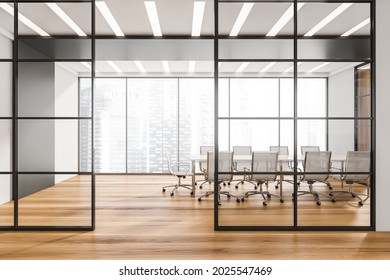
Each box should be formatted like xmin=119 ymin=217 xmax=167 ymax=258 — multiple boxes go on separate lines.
xmin=328 ymin=67 xmax=355 ymax=155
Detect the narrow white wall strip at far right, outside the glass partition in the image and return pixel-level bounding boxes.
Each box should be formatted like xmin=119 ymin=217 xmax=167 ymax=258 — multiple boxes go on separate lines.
xmin=376 ymin=0 xmax=390 ymax=231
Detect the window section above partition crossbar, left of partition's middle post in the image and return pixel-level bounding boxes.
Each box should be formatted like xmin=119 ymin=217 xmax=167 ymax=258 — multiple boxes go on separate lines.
xmin=230 ymin=78 xmax=279 ymax=117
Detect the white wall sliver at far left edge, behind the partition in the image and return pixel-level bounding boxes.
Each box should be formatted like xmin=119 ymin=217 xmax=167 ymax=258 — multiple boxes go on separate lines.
xmin=0 ymin=34 xmax=12 ymax=204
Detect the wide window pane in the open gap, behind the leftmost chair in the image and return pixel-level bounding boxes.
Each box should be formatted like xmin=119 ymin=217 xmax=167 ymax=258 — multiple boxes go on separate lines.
xmin=127 ymin=79 xmax=178 ymax=173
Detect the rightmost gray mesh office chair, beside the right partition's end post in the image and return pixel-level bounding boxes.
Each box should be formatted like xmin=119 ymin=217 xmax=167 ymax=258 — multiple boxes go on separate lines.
xmin=329 ymin=151 xmax=370 ymax=206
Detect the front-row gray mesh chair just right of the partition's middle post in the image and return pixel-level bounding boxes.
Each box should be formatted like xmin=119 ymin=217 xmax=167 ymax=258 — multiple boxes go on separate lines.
xmin=293 ymin=151 xmax=336 ymax=205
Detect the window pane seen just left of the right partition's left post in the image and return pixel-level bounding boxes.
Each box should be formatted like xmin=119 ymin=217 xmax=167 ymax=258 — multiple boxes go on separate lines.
xmin=179 ymin=79 xmax=214 ymax=161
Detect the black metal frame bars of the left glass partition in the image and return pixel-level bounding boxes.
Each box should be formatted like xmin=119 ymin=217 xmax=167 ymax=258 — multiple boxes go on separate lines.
xmin=0 ymin=0 xmax=96 ymax=231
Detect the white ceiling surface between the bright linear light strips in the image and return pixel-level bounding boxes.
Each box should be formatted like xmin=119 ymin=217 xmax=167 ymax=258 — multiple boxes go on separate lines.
xmin=0 ymin=0 xmax=370 ymax=75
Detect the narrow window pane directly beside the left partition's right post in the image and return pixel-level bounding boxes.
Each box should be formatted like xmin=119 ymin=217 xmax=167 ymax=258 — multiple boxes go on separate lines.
xmin=95 ymin=78 xmax=126 ymax=173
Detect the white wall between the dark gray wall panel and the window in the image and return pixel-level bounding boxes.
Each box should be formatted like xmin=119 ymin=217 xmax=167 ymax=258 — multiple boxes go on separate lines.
xmin=55 ymin=64 xmax=78 ymax=183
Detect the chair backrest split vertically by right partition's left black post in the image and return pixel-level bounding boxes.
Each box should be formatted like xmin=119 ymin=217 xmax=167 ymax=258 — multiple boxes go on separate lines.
xmin=207 ymin=151 xmax=233 ymax=181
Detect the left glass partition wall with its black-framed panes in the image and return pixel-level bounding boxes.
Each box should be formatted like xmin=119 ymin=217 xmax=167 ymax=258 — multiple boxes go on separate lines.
xmin=0 ymin=1 xmax=95 ymax=230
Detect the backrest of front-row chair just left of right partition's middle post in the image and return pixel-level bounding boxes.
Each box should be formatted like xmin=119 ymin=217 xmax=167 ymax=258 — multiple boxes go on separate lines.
xmin=252 ymin=151 xmax=278 ymax=181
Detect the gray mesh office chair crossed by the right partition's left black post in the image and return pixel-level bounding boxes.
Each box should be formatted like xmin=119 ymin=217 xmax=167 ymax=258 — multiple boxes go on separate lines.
xmin=198 ymin=151 xmax=240 ymax=205
